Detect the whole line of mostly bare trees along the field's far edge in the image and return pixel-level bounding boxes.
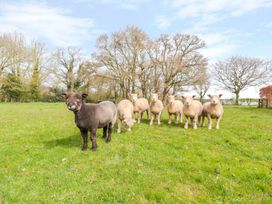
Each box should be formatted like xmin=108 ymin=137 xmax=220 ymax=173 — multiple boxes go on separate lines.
xmin=0 ymin=27 xmax=271 ymax=101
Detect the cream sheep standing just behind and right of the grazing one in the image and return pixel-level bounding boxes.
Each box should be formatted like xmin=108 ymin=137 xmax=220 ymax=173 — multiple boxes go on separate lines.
xmin=131 ymin=94 xmax=150 ymax=123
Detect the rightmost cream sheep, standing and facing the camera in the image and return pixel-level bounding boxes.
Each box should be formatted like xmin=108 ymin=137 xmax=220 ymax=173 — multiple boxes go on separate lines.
xmin=201 ymin=94 xmax=224 ymax=129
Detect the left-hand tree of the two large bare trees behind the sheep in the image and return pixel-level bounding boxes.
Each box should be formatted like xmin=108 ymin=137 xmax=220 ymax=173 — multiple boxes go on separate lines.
xmin=97 ymin=27 xmax=148 ymax=97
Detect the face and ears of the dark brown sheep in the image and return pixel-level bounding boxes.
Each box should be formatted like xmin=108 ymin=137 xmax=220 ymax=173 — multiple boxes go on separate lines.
xmin=62 ymin=93 xmax=87 ymax=111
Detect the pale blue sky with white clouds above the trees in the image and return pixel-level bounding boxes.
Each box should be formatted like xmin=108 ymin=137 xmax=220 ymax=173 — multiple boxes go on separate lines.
xmin=0 ymin=0 xmax=272 ymax=97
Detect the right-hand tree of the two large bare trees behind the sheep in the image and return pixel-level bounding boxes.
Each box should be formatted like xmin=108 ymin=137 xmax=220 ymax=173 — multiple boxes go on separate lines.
xmin=149 ymin=34 xmax=207 ymax=100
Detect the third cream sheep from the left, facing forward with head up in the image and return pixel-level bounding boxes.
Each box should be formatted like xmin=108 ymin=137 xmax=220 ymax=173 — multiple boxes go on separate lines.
xmin=150 ymin=93 xmax=163 ymax=125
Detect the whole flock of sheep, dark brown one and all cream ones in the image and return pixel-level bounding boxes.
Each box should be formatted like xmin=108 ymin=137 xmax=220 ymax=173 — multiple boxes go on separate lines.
xmin=62 ymin=93 xmax=224 ymax=150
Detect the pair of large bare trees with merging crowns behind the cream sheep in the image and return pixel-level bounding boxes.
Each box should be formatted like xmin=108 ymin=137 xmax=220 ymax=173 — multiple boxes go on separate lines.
xmin=96 ymin=27 xmax=207 ymax=99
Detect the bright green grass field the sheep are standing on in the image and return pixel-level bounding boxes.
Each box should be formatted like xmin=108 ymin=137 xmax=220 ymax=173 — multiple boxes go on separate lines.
xmin=0 ymin=103 xmax=272 ymax=203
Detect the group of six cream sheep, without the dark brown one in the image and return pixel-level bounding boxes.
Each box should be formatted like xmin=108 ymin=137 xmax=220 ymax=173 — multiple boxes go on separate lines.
xmin=117 ymin=94 xmax=223 ymax=132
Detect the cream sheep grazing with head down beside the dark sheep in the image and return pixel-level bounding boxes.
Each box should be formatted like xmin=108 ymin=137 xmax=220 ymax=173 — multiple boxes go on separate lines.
xmin=117 ymin=99 xmax=134 ymax=133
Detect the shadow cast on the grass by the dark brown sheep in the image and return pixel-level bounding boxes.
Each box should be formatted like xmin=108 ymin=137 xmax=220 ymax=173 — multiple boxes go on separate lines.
xmin=44 ymin=134 xmax=82 ymax=148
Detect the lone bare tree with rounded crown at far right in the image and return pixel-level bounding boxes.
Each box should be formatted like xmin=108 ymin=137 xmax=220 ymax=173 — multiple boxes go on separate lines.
xmin=213 ymin=56 xmax=271 ymax=105
